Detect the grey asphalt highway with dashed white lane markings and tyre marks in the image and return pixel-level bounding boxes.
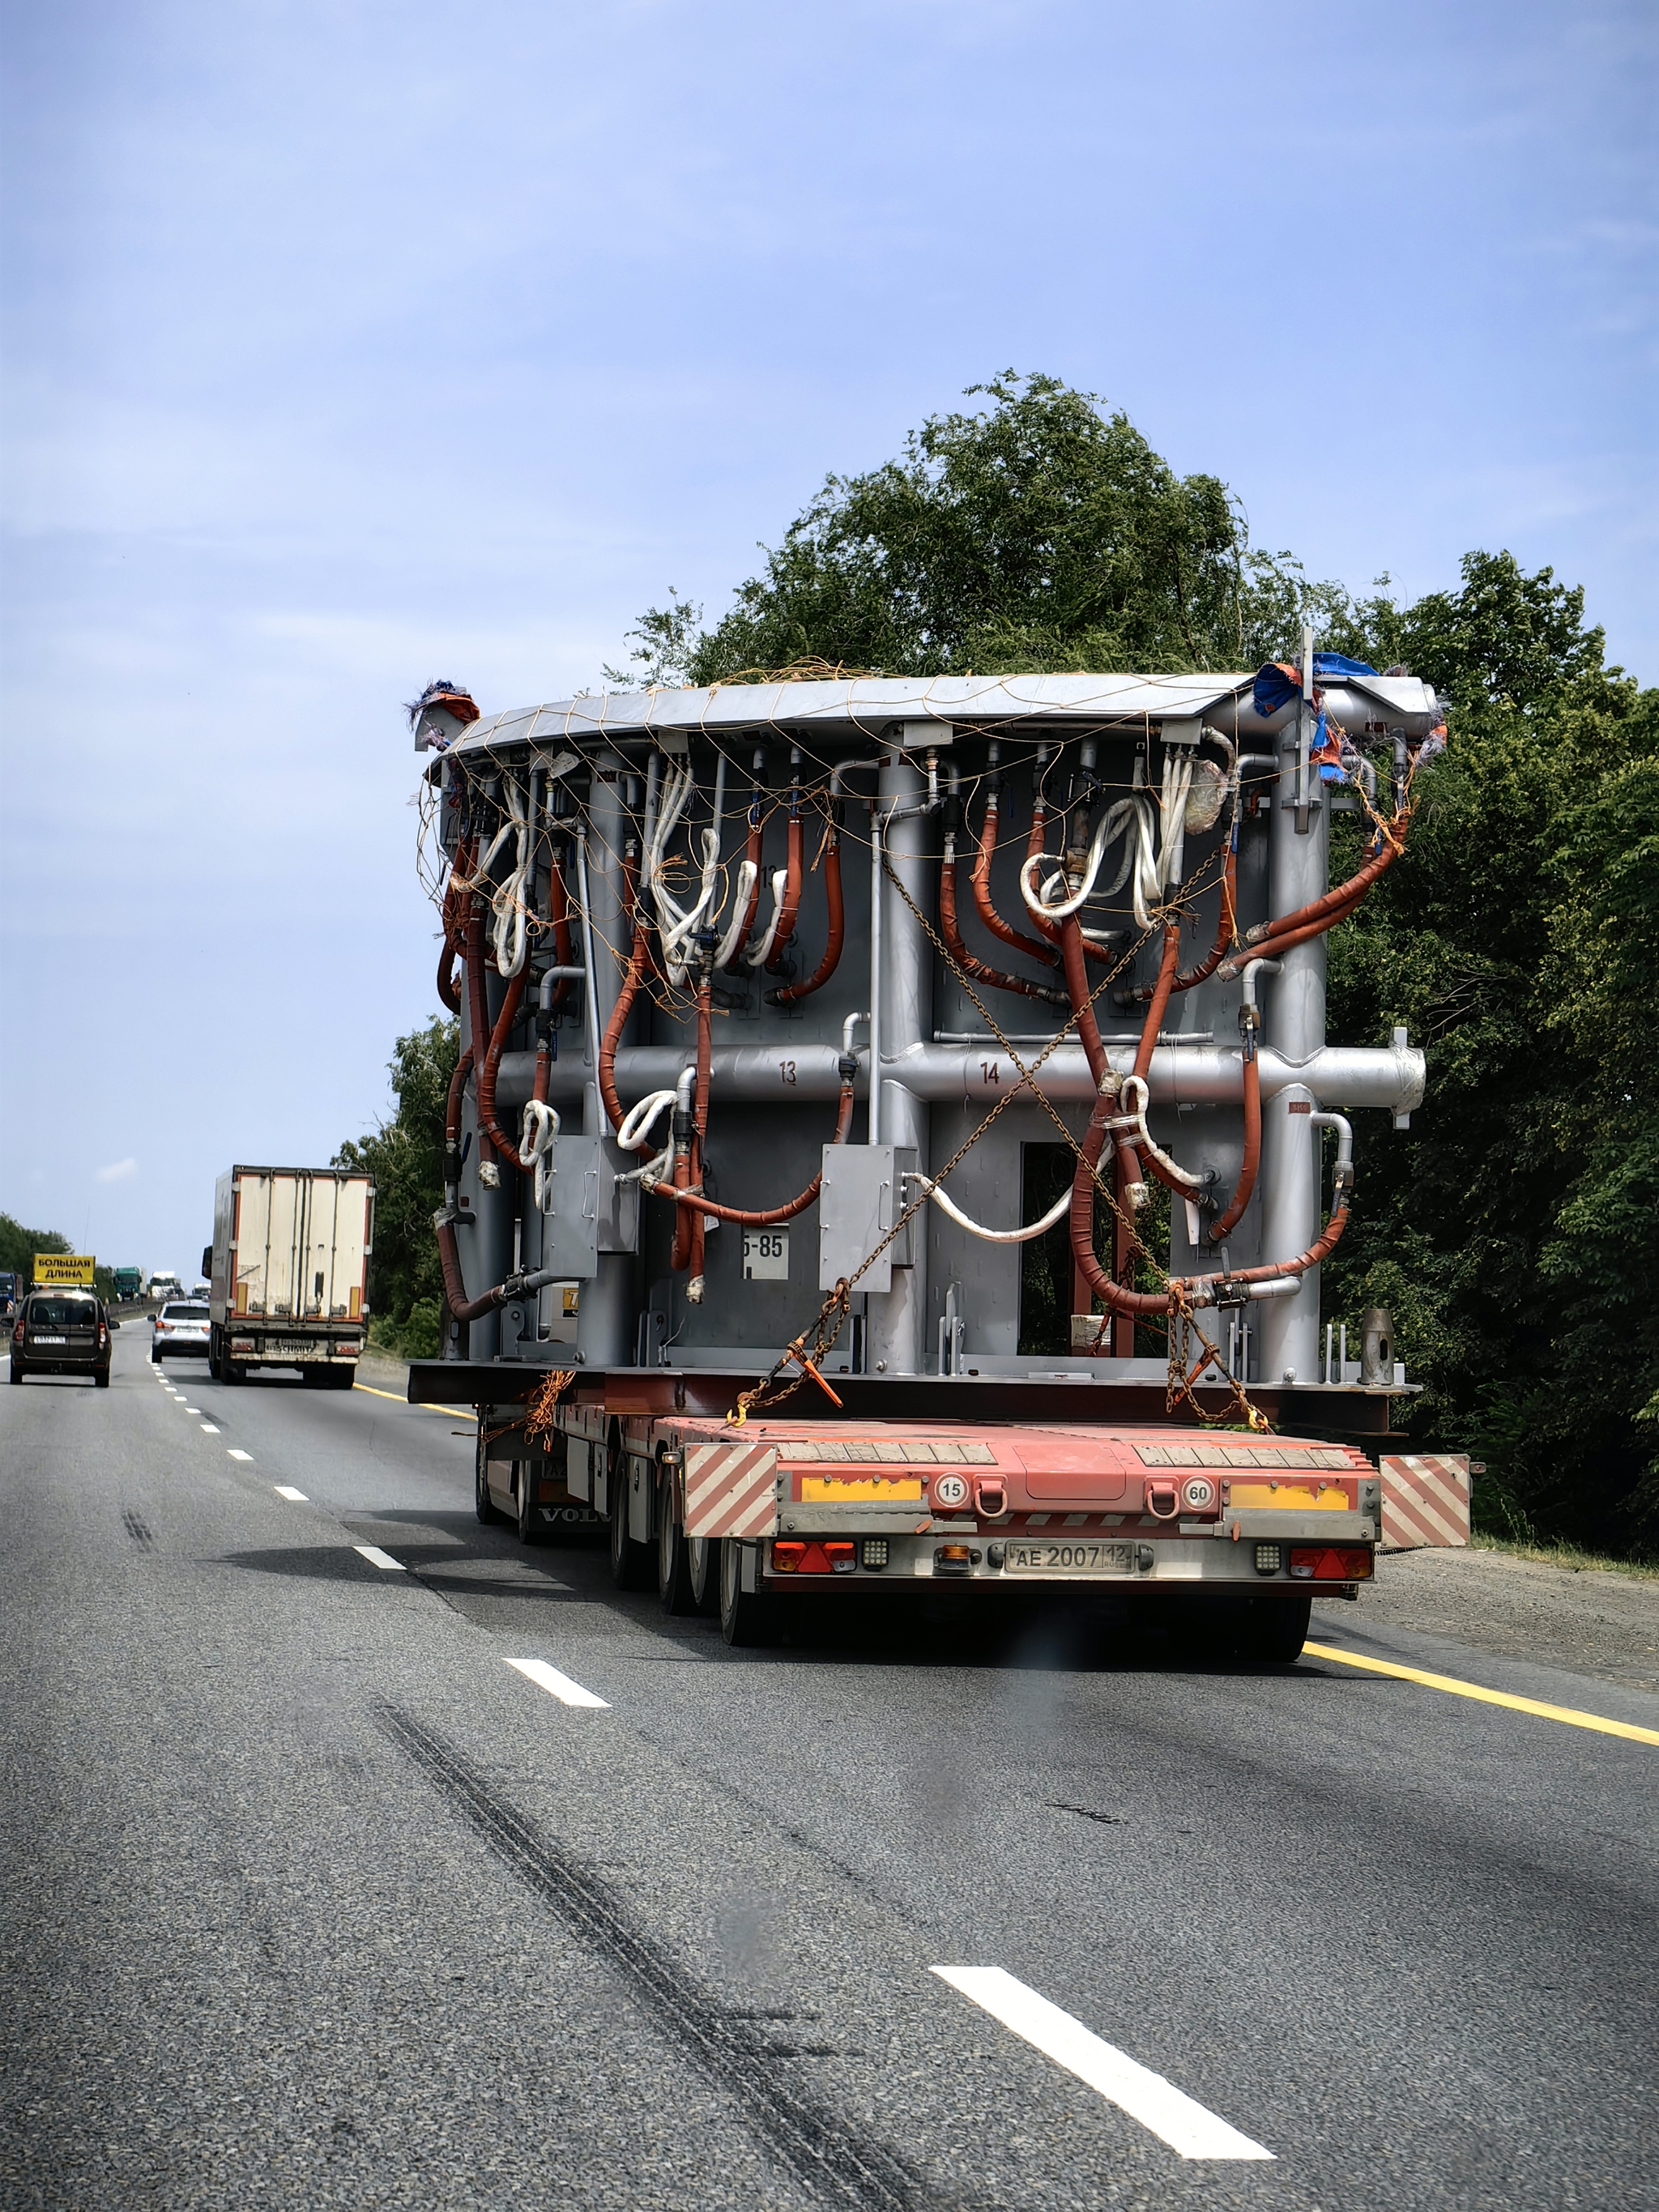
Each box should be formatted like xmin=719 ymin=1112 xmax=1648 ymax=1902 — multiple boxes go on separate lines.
xmin=0 ymin=1325 xmax=1659 ymax=2212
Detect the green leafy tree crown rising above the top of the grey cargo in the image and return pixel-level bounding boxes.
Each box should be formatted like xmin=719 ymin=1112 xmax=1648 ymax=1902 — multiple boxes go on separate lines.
xmin=632 ymin=369 xmax=1347 ymax=684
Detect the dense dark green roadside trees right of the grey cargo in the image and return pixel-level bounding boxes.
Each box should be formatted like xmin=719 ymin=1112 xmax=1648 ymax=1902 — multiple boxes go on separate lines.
xmin=1325 ymin=553 xmax=1659 ymax=1549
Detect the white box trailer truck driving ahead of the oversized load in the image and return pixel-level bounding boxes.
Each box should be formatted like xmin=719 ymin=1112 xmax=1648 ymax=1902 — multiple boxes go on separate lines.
xmin=201 ymin=1168 xmax=373 ymax=1389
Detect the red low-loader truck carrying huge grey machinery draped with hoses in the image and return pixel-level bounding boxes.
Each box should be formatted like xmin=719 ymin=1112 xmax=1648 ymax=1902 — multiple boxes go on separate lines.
xmin=409 ymin=637 xmax=1444 ymax=1657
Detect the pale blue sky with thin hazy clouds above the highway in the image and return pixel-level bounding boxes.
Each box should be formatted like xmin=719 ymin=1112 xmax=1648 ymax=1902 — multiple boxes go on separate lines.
xmin=0 ymin=0 xmax=1659 ymax=1270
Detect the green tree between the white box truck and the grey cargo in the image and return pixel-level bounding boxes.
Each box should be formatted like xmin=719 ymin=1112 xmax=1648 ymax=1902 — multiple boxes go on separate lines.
xmin=334 ymin=1020 xmax=460 ymax=1358
